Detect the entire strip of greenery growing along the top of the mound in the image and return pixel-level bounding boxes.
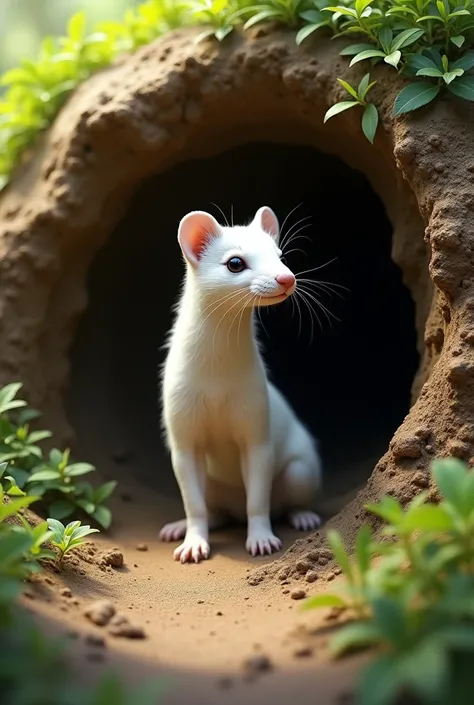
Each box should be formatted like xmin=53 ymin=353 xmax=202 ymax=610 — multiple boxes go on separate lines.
xmin=0 ymin=0 xmax=474 ymax=179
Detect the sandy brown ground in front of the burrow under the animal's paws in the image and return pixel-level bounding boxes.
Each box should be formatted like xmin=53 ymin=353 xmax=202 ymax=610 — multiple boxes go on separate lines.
xmin=22 ymin=454 xmax=366 ymax=705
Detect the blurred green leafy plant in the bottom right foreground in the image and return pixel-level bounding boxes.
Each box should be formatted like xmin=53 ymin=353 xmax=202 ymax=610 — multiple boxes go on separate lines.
xmin=304 ymin=459 xmax=474 ymax=705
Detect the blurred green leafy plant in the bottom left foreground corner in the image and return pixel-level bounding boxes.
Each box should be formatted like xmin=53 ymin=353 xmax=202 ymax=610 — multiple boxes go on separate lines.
xmin=0 ymin=456 xmax=163 ymax=705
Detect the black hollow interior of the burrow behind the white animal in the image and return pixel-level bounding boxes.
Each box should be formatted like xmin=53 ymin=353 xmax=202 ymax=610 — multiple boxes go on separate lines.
xmin=67 ymin=144 xmax=418 ymax=516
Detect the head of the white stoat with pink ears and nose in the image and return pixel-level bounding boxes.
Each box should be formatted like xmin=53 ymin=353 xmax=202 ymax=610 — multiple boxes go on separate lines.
xmin=178 ymin=206 xmax=296 ymax=306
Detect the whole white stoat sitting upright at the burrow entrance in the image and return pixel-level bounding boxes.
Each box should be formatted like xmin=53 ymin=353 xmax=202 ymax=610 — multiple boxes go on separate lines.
xmin=160 ymin=207 xmax=321 ymax=563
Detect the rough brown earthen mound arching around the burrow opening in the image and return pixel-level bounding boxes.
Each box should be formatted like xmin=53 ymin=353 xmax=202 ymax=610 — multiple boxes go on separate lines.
xmin=0 ymin=29 xmax=474 ymax=628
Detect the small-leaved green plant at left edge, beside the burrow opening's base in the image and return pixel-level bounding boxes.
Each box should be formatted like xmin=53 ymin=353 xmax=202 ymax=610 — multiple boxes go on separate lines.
xmin=0 ymin=383 xmax=117 ymax=529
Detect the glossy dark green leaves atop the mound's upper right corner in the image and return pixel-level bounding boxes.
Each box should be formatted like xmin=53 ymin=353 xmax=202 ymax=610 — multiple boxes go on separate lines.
xmin=297 ymin=0 xmax=474 ymax=133
